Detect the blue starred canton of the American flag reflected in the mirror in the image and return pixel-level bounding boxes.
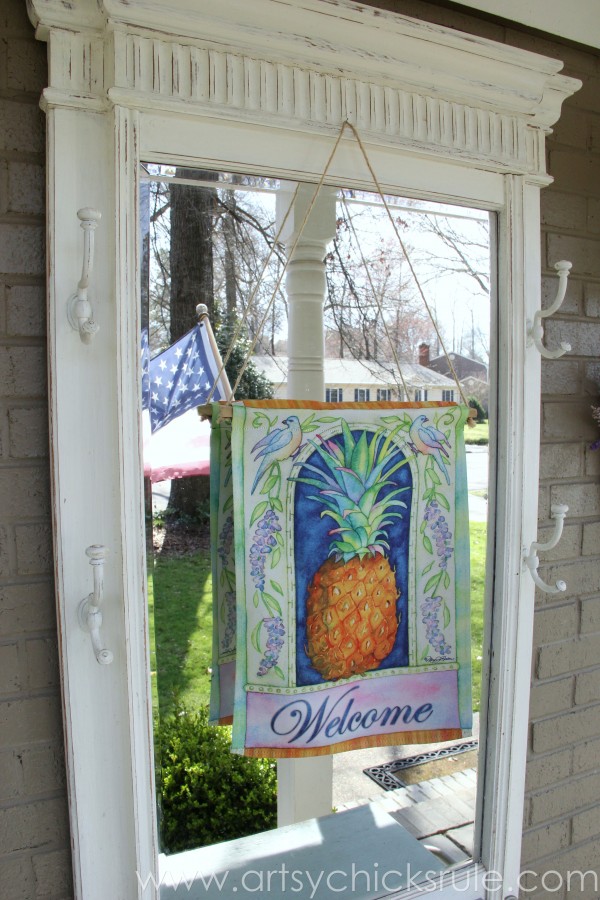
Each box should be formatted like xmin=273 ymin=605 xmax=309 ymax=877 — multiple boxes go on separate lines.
xmin=141 ymin=322 xmax=227 ymax=432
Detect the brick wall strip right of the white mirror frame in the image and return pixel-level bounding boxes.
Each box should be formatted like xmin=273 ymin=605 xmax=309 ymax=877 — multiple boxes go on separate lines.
xmin=507 ymin=31 xmax=600 ymax=900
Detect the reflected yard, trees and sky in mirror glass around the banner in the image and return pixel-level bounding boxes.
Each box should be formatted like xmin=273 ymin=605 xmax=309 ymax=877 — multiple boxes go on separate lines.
xmin=140 ymin=163 xmax=494 ymax=880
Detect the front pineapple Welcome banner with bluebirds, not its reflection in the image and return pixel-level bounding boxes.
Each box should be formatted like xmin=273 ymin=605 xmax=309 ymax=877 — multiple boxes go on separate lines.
xmin=232 ymin=400 xmax=472 ymax=757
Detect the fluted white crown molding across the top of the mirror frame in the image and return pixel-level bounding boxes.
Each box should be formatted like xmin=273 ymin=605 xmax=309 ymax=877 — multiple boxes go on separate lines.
xmin=28 ymin=0 xmax=580 ymax=177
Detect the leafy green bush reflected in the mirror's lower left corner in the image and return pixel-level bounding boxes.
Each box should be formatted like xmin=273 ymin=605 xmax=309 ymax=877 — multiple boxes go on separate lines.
xmin=156 ymin=707 xmax=277 ymax=853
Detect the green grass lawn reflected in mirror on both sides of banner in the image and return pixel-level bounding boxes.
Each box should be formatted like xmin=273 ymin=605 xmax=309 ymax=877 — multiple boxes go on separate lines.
xmin=149 ymin=522 xmax=486 ymax=716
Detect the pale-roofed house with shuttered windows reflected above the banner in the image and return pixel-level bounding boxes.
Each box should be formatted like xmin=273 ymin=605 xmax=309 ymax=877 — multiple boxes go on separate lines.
xmin=252 ymin=356 xmax=458 ymax=403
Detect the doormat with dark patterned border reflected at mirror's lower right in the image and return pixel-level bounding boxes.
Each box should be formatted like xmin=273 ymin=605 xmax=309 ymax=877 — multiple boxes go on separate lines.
xmin=363 ymin=741 xmax=479 ymax=791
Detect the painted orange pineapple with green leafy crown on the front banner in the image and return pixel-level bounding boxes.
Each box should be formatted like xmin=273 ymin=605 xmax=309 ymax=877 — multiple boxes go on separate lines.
xmin=294 ymin=422 xmax=408 ymax=681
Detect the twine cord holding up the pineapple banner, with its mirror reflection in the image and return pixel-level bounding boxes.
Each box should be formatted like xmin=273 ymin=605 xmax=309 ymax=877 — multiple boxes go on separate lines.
xmin=207 ymin=121 xmax=477 ymax=427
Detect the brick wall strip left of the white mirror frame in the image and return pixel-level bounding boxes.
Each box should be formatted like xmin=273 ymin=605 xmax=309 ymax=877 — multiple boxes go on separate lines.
xmin=0 ymin=0 xmax=72 ymax=900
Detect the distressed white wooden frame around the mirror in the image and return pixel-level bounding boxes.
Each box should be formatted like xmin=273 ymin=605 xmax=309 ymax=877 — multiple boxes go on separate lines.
xmin=28 ymin=0 xmax=579 ymax=900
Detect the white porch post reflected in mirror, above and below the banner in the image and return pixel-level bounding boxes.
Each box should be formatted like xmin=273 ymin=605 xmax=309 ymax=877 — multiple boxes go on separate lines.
xmin=277 ymin=184 xmax=336 ymax=825
